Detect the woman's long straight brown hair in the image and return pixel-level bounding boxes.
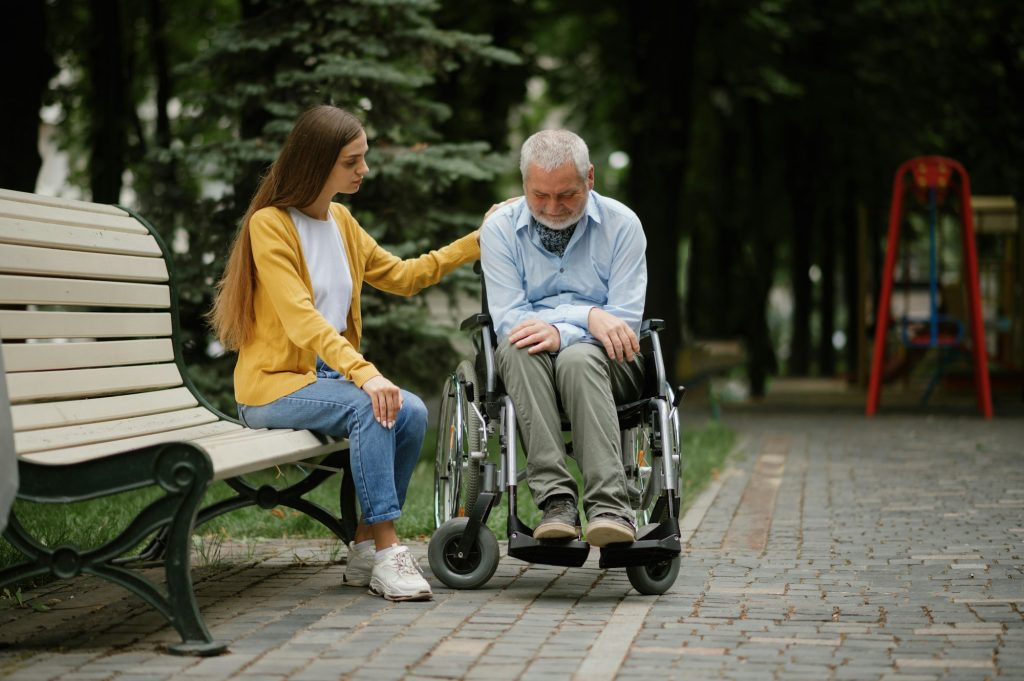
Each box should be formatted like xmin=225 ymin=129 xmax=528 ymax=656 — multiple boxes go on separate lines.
xmin=207 ymin=104 xmax=362 ymax=350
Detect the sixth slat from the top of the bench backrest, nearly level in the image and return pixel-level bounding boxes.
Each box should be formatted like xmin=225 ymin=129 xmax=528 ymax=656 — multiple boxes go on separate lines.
xmin=0 ymin=310 xmax=171 ymax=340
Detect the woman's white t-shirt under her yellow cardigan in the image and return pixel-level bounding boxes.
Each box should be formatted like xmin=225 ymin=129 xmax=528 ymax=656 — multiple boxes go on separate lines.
xmin=288 ymin=208 xmax=352 ymax=333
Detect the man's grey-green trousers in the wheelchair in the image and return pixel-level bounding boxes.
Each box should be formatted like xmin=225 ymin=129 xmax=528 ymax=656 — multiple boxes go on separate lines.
xmin=498 ymin=339 xmax=643 ymax=520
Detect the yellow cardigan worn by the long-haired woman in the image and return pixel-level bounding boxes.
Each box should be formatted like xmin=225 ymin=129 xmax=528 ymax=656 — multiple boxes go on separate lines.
xmin=234 ymin=204 xmax=480 ymax=407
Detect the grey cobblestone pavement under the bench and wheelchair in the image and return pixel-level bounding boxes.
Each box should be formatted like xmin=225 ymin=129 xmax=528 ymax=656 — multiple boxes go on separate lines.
xmin=0 ymin=414 xmax=1024 ymax=681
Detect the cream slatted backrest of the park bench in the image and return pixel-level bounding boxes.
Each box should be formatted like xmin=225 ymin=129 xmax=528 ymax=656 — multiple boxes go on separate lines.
xmin=0 ymin=189 xmax=227 ymax=463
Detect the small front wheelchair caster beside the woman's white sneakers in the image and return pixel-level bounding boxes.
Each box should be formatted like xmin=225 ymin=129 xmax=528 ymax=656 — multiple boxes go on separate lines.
xmin=427 ymin=517 xmax=501 ymax=589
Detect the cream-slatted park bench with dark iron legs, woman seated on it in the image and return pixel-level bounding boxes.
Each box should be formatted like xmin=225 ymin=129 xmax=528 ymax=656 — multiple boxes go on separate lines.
xmin=0 ymin=189 xmax=355 ymax=654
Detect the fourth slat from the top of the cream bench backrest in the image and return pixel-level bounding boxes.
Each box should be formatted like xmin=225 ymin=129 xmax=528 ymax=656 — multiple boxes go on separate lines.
xmin=0 ymin=244 xmax=167 ymax=282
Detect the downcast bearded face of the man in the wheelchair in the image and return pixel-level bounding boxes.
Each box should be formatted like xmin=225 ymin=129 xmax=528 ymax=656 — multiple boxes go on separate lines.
xmin=522 ymin=162 xmax=594 ymax=229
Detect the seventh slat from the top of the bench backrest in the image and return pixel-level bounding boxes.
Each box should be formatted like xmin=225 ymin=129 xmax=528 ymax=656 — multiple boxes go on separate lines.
xmin=3 ymin=338 xmax=174 ymax=373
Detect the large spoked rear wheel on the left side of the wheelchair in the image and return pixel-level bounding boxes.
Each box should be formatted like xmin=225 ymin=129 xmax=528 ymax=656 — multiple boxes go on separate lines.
xmin=434 ymin=359 xmax=480 ymax=527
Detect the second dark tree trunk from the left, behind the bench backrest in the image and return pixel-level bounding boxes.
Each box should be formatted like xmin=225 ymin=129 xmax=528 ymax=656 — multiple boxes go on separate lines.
xmin=88 ymin=0 xmax=131 ymax=204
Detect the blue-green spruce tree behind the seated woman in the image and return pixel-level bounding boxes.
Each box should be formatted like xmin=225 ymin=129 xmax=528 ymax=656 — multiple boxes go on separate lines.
xmin=131 ymin=0 xmax=515 ymax=399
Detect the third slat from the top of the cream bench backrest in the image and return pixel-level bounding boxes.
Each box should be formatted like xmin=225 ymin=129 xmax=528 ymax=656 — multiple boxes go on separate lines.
xmin=0 ymin=215 xmax=163 ymax=257
